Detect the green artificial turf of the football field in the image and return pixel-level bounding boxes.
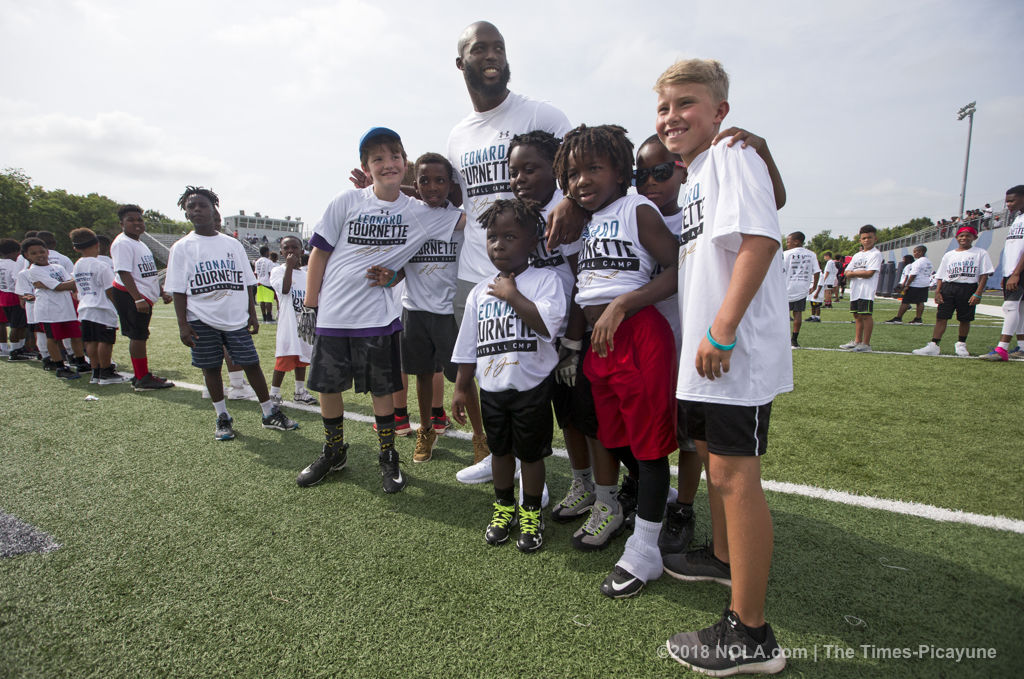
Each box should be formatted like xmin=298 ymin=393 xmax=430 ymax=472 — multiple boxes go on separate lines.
xmin=0 ymin=303 xmax=1024 ymax=678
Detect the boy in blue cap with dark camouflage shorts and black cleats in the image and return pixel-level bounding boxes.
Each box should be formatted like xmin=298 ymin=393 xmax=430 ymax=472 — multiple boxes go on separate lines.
xmin=297 ymin=127 xmax=465 ymax=493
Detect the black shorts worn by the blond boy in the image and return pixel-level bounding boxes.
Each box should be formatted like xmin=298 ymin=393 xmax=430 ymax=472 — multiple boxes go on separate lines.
xmin=676 ymin=400 xmax=771 ymax=457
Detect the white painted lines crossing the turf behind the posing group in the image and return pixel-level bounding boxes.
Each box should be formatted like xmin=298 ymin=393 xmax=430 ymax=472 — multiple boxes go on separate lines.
xmin=174 ymin=378 xmax=1024 ymax=535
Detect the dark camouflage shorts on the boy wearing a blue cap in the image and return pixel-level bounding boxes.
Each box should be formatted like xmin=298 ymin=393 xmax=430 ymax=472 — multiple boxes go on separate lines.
xmin=306 ymin=333 xmax=401 ymax=396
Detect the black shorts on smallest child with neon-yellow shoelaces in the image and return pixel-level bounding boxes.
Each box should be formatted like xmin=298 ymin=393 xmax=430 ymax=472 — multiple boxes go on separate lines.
xmin=480 ymin=377 xmax=554 ymax=462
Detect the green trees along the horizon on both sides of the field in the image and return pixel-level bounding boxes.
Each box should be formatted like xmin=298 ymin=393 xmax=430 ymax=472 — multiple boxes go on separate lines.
xmin=0 ymin=168 xmax=934 ymax=256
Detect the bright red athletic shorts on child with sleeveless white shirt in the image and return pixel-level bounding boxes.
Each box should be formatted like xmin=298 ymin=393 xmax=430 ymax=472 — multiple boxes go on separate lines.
xmin=583 ymin=306 xmax=678 ymax=460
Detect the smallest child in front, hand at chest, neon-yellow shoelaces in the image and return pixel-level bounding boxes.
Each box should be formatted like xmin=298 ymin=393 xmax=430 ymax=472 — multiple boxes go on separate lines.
xmin=452 ymin=200 xmax=566 ymax=552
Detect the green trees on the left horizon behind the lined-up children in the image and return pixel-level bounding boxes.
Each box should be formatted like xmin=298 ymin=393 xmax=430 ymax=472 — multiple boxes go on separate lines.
xmin=0 ymin=168 xmax=191 ymax=252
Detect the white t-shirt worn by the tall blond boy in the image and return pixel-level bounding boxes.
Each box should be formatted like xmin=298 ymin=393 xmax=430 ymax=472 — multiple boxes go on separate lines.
xmin=676 ymin=144 xmax=793 ymax=406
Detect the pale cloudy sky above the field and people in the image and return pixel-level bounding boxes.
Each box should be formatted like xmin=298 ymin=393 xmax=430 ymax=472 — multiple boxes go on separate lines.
xmin=0 ymin=0 xmax=1024 ymax=236
